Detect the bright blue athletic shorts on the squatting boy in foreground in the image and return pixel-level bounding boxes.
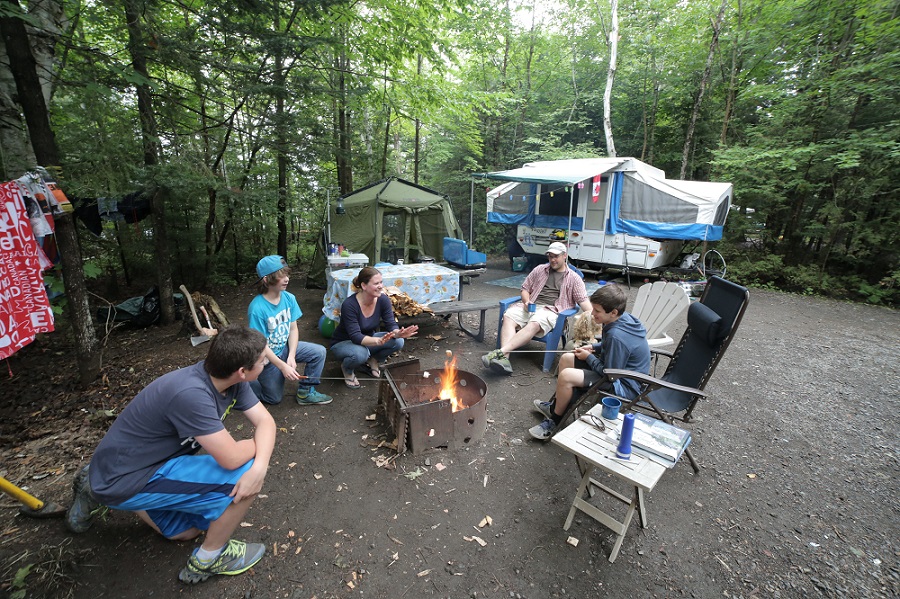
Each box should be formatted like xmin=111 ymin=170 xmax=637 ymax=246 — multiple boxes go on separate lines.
xmin=109 ymin=455 xmax=253 ymax=538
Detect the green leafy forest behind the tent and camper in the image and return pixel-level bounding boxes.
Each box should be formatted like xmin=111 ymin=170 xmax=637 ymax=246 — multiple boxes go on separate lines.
xmin=0 ymin=0 xmax=900 ymax=378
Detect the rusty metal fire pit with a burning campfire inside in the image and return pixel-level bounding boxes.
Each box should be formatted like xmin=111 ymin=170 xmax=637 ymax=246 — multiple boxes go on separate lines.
xmin=378 ymin=358 xmax=487 ymax=454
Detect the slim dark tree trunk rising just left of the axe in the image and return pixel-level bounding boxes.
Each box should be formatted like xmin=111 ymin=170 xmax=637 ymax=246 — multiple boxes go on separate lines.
xmin=125 ymin=0 xmax=175 ymax=324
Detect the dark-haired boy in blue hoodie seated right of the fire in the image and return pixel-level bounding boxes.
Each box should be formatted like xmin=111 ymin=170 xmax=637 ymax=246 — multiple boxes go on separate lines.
xmin=528 ymin=284 xmax=650 ymax=441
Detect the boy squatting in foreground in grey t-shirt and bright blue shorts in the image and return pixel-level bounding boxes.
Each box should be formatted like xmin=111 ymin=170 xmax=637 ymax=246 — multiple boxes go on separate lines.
xmin=66 ymin=326 xmax=275 ymax=584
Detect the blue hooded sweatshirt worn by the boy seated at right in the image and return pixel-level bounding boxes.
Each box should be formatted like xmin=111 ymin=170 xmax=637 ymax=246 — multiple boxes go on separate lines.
xmin=587 ymin=312 xmax=650 ymax=399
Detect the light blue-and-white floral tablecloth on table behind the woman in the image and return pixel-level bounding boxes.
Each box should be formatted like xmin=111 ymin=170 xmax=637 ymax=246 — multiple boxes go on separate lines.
xmin=322 ymin=263 xmax=459 ymax=320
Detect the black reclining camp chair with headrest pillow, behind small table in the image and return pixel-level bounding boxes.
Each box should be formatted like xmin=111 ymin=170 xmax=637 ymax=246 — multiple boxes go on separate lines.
xmin=563 ymin=277 xmax=750 ymax=472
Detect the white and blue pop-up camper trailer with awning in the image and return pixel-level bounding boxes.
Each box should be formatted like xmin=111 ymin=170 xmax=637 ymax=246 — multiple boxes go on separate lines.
xmin=474 ymin=158 xmax=732 ymax=272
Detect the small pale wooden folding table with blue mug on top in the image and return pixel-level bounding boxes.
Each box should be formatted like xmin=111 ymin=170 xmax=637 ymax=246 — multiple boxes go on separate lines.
xmin=552 ymin=404 xmax=666 ymax=563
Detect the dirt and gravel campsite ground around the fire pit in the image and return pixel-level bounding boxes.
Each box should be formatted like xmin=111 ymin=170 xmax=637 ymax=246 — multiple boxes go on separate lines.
xmin=0 ymin=264 xmax=900 ymax=599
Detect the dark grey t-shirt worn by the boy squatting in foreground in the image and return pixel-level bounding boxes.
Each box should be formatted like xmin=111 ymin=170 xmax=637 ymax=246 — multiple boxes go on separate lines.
xmin=90 ymin=362 xmax=259 ymax=505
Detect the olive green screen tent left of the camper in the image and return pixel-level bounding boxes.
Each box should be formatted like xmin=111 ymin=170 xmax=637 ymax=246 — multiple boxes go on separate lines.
xmin=307 ymin=177 xmax=462 ymax=288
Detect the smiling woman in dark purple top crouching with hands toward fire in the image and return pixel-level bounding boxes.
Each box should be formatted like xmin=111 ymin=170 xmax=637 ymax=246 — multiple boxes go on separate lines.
xmin=331 ymin=266 xmax=419 ymax=389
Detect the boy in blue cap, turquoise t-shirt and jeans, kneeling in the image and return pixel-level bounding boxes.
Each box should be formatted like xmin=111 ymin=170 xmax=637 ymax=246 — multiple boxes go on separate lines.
xmin=247 ymin=256 xmax=332 ymax=406
